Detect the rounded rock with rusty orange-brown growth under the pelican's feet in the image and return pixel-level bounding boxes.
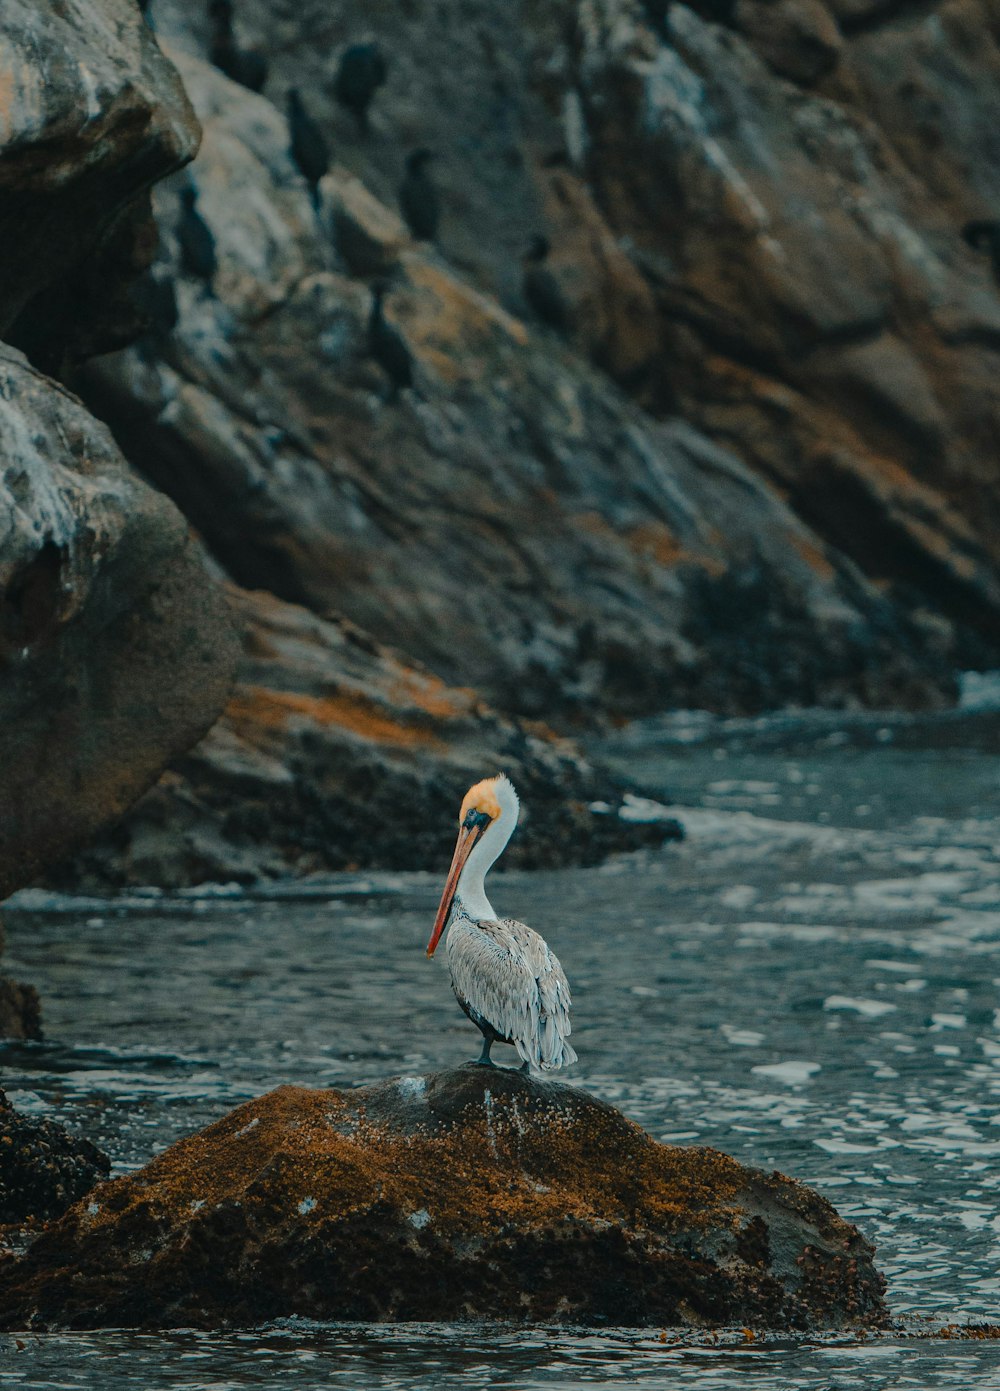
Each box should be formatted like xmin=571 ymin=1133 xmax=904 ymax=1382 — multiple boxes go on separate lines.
xmin=0 ymin=1066 xmax=885 ymax=1328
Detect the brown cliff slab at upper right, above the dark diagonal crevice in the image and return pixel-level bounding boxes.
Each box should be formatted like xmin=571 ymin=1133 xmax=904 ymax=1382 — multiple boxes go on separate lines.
xmin=567 ymin=0 xmax=1000 ymax=665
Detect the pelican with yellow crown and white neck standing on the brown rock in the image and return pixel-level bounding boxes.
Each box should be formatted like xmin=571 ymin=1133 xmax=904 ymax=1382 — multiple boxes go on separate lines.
xmin=427 ymin=773 xmax=577 ymax=1072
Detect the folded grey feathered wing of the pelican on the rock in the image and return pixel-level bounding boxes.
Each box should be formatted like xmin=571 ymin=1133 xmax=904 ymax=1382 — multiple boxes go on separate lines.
xmin=448 ymin=918 xmax=576 ymax=1071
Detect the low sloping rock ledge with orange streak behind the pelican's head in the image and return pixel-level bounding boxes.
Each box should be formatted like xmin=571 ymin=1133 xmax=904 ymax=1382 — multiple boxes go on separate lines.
xmin=49 ymin=590 xmax=682 ymax=892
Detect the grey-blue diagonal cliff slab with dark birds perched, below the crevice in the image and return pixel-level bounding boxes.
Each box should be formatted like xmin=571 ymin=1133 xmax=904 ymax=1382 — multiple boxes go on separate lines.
xmin=82 ymin=39 xmax=968 ymax=721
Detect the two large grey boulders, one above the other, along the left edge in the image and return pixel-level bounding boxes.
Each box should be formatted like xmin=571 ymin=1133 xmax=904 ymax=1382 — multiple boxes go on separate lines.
xmin=0 ymin=0 xmax=235 ymax=895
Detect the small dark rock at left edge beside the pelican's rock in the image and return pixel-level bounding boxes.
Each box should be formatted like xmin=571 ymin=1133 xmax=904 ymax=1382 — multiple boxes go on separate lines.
xmin=0 ymin=1092 xmax=111 ymax=1223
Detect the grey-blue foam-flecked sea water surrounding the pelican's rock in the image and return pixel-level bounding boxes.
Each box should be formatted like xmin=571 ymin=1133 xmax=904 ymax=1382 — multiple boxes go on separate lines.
xmin=0 ymin=701 xmax=1000 ymax=1391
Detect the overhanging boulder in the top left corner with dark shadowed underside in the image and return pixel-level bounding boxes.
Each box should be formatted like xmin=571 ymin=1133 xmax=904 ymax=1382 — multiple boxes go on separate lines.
xmin=0 ymin=0 xmax=199 ymax=371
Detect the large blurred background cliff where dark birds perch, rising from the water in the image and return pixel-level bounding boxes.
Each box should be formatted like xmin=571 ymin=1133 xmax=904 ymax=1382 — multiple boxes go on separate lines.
xmin=78 ymin=0 xmax=1000 ymax=719
